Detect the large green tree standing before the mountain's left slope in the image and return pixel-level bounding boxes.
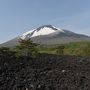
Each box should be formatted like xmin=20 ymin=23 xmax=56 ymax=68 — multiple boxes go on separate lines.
xmin=15 ymin=39 xmax=38 ymax=57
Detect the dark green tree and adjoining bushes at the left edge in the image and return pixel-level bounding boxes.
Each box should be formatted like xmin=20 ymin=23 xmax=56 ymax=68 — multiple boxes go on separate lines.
xmin=0 ymin=39 xmax=38 ymax=59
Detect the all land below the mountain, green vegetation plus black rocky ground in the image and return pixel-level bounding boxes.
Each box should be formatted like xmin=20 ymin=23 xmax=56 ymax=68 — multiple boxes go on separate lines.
xmin=0 ymin=40 xmax=90 ymax=90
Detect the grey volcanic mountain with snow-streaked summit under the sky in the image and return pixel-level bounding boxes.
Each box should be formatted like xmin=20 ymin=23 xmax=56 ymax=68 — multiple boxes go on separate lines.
xmin=1 ymin=25 xmax=90 ymax=47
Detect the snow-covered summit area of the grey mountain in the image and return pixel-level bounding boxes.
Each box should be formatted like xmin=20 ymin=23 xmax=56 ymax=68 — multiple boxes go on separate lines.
xmin=21 ymin=25 xmax=64 ymax=39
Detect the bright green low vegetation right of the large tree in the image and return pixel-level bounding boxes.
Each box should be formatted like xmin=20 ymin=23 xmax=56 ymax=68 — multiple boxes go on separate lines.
xmin=39 ymin=42 xmax=90 ymax=56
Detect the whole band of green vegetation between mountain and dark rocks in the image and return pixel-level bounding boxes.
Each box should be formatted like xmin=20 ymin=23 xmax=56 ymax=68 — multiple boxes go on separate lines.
xmin=0 ymin=39 xmax=90 ymax=57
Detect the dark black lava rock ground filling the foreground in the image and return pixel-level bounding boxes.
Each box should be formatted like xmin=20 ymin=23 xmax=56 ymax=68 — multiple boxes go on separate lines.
xmin=0 ymin=55 xmax=90 ymax=90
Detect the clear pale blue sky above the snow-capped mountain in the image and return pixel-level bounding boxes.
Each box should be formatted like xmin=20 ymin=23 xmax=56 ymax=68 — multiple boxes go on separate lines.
xmin=0 ymin=0 xmax=90 ymax=43
